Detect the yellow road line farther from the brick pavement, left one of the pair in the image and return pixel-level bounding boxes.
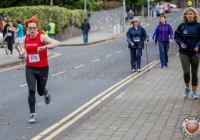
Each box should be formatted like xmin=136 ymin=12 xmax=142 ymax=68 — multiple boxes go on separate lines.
xmin=32 ymin=60 xmax=158 ymax=140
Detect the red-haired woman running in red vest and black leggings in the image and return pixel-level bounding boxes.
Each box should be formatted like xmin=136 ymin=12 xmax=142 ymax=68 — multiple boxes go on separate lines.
xmin=20 ymin=16 xmax=60 ymax=123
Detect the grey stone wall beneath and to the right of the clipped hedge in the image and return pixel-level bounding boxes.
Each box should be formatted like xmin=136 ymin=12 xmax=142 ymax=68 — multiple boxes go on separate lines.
xmin=55 ymin=7 xmax=123 ymax=41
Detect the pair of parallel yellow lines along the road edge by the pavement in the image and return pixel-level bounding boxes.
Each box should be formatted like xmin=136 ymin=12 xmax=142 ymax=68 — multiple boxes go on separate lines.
xmin=31 ymin=60 xmax=159 ymax=140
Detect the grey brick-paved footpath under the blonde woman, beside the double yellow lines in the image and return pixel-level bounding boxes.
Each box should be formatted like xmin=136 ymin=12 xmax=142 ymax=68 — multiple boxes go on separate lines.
xmin=66 ymin=57 xmax=200 ymax=140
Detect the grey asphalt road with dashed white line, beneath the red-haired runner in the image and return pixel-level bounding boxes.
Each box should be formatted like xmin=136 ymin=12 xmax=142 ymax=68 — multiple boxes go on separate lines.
xmin=0 ymin=12 xmax=181 ymax=140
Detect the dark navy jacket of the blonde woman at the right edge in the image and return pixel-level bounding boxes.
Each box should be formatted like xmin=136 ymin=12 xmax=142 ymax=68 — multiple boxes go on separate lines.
xmin=174 ymin=20 xmax=200 ymax=55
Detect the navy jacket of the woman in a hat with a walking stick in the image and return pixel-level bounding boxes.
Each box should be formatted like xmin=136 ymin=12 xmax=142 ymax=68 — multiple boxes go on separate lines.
xmin=126 ymin=25 xmax=147 ymax=49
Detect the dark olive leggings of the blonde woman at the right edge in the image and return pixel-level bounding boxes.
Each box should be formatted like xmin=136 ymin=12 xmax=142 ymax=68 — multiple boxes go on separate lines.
xmin=180 ymin=54 xmax=199 ymax=86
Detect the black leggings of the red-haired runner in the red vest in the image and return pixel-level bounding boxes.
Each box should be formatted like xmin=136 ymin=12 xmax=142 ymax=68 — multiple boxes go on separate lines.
xmin=26 ymin=66 xmax=49 ymax=113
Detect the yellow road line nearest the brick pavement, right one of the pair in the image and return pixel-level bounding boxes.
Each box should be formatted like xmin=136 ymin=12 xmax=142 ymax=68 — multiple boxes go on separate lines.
xmin=44 ymin=61 xmax=158 ymax=140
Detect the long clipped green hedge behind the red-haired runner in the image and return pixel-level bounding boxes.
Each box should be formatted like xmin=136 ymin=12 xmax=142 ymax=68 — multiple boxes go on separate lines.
xmin=0 ymin=6 xmax=85 ymax=33
